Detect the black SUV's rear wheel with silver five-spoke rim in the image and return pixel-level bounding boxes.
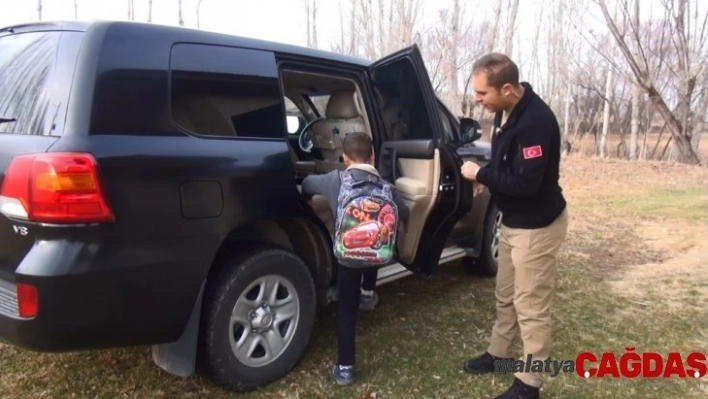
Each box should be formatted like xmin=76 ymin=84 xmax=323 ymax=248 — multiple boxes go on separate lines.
xmin=199 ymin=245 xmax=316 ymax=392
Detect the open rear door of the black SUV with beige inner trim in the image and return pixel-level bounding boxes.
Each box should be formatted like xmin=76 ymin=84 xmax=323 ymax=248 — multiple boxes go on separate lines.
xmin=369 ymin=45 xmax=472 ymax=275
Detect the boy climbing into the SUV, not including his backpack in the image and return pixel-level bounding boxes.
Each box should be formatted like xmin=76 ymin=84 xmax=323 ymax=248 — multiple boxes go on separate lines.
xmin=302 ymin=132 xmax=408 ymax=385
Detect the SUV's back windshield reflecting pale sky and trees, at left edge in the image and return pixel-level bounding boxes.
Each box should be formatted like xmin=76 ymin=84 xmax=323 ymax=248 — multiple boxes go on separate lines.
xmin=0 ymin=31 xmax=82 ymax=136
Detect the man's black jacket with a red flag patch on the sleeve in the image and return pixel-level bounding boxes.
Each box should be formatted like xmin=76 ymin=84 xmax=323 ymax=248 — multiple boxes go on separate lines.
xmin=477 ymin=82 xmax=566 ymax=229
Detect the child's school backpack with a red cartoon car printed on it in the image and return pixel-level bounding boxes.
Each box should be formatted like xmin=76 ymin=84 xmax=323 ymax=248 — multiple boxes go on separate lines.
xmin=334 ymin=171 xmax=398 ymax=267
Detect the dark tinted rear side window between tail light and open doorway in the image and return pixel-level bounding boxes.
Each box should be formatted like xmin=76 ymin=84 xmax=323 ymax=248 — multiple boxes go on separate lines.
xmin=170 ymin=44 xmax=288 ymax=137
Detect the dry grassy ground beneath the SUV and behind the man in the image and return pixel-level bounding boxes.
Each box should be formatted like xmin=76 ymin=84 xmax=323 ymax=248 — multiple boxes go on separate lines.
xmin=0 ymin=156 xmax=708 ymax=398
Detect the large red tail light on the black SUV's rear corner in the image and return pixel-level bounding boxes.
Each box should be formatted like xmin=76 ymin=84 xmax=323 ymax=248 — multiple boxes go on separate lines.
xmin=0 ymin=153 xmax=114 ymax=223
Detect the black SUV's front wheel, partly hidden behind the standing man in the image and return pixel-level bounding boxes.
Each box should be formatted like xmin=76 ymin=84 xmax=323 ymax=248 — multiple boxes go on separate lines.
xmin=462 ymin=202 xmax=501 ymax=277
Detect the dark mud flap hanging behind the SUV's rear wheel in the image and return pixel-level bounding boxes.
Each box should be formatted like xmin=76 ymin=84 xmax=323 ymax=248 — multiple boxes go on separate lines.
xmin=152 ymin=281 xmax=206 ymax=377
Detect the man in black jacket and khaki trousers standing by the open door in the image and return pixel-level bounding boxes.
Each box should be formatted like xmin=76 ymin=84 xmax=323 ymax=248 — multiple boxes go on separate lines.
xmin=462 ymin=53 xmax=568 ymax=399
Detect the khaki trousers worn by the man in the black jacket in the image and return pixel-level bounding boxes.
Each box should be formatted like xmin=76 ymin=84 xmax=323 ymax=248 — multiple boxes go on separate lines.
xmin=488 ymin=208 xmax=568 ymax=387
